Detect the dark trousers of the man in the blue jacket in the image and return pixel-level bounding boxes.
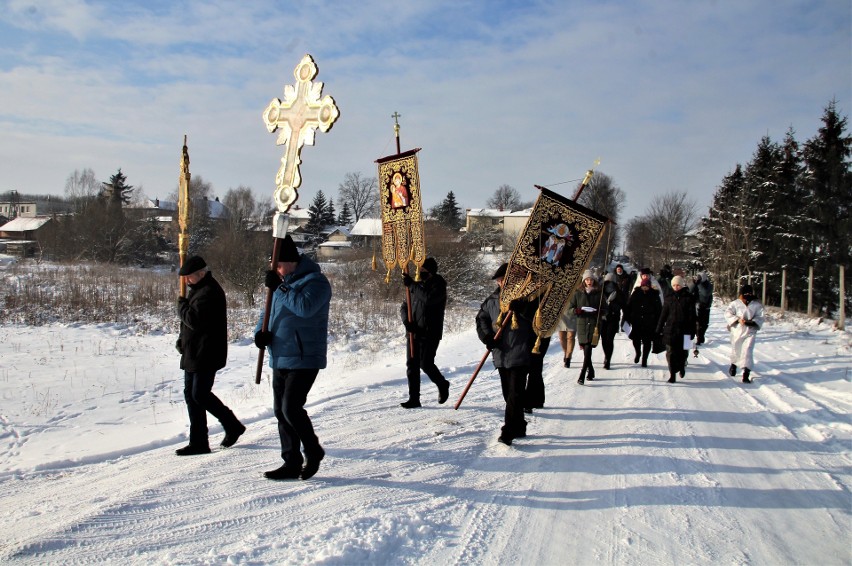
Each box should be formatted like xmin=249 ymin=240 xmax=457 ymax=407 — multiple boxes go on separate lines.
xmin=272 ymin=368 xmax=322 ymax=467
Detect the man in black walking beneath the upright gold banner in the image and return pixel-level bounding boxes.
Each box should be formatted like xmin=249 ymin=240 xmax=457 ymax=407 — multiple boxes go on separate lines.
xmin=400 ymin=257 xmax=450 ymax=409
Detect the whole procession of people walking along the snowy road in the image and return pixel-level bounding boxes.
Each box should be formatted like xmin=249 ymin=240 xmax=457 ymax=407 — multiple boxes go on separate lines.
xmin=171 ymin=243 xmax=765 ymax=480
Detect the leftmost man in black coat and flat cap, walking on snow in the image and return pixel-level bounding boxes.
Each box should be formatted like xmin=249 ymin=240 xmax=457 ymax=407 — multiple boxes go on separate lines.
xmin=175 ymin=256 xmax=246 ymax=456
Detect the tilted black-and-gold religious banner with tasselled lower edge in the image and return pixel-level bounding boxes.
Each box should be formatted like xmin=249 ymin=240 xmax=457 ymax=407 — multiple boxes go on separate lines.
xmin=500 ymin=187 xmax=608 ymax=344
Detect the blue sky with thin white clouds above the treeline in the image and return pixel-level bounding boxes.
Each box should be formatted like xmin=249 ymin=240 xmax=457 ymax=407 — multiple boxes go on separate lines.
xmin=0 ymin=0 xmax=852 ymax=226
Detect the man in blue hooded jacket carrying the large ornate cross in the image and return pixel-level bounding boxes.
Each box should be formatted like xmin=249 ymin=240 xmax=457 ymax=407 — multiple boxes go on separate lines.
xmin=254 ymin=235 xmax=331 ymax=480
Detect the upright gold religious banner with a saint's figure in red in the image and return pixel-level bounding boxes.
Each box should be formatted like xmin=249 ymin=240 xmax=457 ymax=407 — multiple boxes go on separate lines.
xmin=376 ymin=148 xmax=426 ymax=281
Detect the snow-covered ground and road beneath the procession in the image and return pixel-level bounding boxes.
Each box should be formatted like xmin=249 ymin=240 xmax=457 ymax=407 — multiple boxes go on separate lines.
xmin=0 ymin=308 xmax=852 ymax=566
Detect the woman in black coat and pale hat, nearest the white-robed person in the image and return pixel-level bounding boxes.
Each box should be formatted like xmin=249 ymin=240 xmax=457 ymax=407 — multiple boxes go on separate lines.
xmin=657 ymin=275 xmax=696 ymax=383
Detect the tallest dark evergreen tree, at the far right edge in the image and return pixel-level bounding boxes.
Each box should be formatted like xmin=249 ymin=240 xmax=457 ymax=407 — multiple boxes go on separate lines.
xmin=802 ymin=100 xmax=852 ymax=315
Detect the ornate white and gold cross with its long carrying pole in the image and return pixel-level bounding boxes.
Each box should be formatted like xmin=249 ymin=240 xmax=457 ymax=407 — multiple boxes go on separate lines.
xmin=254 ymin=55 xmax=340 ymax=383
